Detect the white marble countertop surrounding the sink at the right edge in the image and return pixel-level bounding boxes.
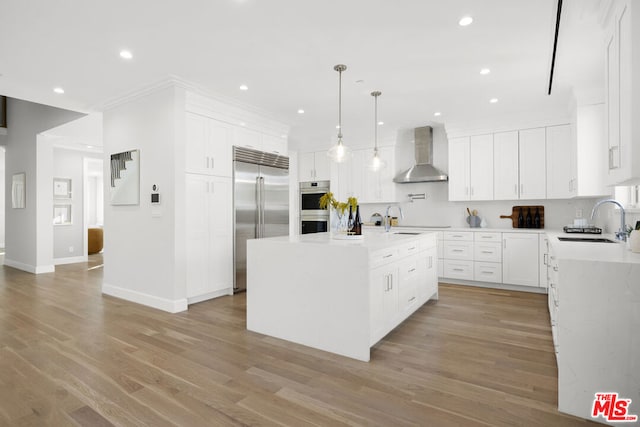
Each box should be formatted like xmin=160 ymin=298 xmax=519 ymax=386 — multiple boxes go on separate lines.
xmin=547 ymin=232 xmax=640 ymax=264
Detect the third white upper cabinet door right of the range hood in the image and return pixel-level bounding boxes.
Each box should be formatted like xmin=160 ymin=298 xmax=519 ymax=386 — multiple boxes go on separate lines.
xmin=493 ymin=131 xmax=520 ymax=200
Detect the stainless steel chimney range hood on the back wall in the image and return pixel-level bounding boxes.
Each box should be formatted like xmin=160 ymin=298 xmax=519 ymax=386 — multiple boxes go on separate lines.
xmin=393 ymin=126 xmax=448 ymax=184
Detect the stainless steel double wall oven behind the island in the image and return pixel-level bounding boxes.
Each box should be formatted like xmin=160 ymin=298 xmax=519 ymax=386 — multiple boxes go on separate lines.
xmin=300 ymin=181 xmax=331 ymax=234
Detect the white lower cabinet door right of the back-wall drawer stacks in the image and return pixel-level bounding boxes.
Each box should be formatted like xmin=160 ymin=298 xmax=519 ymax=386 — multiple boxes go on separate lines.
xmin=502 ymin=233 xmax=540 ymax=286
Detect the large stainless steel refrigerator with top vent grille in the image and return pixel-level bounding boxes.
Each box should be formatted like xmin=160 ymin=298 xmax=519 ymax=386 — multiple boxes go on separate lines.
xmin=233 ymin=147 xmax=289 ymax=292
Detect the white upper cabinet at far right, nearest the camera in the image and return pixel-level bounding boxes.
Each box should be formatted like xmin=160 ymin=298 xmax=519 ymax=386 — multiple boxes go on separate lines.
xmin=605 ymin=0 xmax=640 ymax=185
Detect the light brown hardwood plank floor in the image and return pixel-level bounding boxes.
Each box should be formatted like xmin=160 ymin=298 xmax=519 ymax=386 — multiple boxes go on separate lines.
xmin=0 ymin=256 xmax=589 ymax=426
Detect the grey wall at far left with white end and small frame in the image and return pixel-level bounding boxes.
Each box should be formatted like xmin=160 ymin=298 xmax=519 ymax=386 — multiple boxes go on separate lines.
xmin=5 ymin=98 xmax=83 ymax=273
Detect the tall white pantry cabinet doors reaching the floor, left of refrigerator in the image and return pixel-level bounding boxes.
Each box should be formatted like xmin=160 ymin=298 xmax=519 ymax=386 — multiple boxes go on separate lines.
xmin=185 ymin=174 xmax=233 ymax=304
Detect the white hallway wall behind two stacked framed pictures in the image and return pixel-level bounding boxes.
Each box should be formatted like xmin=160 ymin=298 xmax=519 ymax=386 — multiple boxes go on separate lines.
xmin=53 ymin=147 xmax=102 ymax=263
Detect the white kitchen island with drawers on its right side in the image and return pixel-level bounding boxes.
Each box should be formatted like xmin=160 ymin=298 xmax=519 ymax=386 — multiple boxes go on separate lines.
xmin=247 ymin=232 xmax=438 ymax=361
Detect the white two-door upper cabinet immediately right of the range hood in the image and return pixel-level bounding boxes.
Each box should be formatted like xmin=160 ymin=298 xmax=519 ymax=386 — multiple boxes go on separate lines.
xmin=449 ymin=134 xmax=493 ymax=200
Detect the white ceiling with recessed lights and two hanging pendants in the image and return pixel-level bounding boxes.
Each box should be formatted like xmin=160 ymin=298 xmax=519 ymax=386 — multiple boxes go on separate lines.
xmin=0 ymin=0 xmax=603 ymax=149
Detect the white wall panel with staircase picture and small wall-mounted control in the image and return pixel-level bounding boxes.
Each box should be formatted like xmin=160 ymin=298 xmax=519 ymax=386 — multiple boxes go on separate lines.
xmin=102 ymin=87 xmax=187 ymax=312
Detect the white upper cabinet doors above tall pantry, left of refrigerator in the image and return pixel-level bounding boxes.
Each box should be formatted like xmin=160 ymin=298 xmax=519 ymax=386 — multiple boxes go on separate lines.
xmin=185 ymin=112 xmax=233 ymax=176
